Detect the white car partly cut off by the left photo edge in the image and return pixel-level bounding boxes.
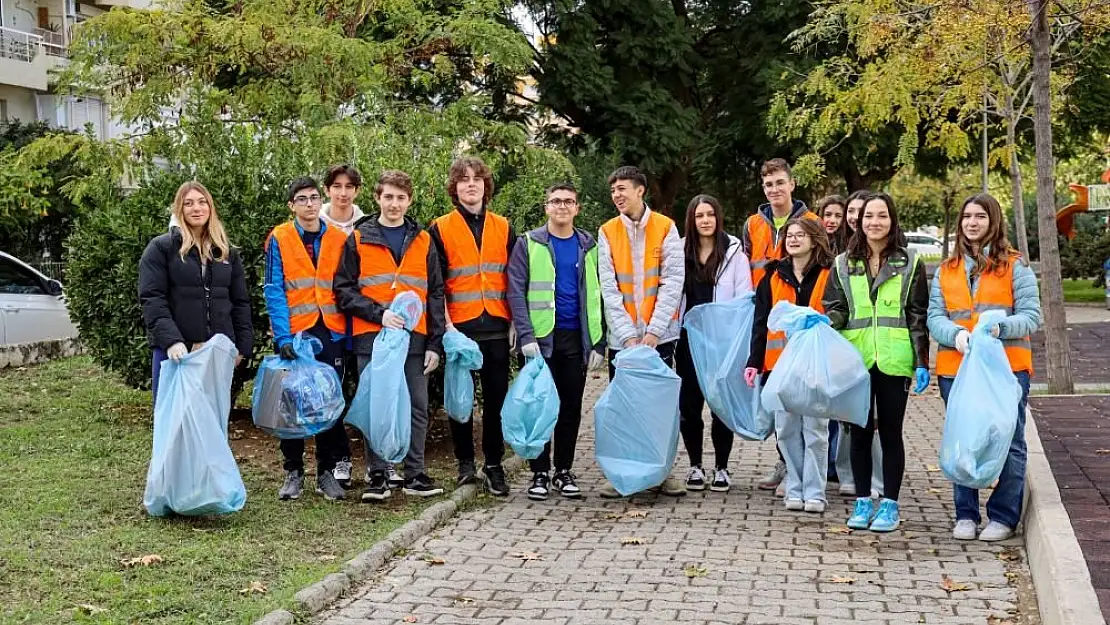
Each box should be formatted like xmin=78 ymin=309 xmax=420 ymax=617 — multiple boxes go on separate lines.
xmin=0 ymin=252 xmax=77 ymax=345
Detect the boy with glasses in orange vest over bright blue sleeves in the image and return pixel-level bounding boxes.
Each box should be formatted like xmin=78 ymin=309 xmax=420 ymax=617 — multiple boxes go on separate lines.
xmin=263 ymin=178 xmax=347 ymax=500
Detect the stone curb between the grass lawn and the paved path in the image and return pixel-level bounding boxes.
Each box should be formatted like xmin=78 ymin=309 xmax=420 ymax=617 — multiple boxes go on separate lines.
xmin=254 ymin=455 xmax=524 ymax=625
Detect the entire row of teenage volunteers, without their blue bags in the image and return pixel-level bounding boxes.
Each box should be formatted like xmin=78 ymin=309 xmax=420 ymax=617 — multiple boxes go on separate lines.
xmin=139 ymin=157 xmax=1040 ymax=541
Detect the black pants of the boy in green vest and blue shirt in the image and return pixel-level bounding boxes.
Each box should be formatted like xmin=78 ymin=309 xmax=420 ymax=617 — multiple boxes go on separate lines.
xmin=528 ymin=330 xmax=586 ymax=473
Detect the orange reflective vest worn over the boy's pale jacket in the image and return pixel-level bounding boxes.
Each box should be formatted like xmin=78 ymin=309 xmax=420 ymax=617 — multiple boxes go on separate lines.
xmin=602 ymin=211 xmax=678 ymax=325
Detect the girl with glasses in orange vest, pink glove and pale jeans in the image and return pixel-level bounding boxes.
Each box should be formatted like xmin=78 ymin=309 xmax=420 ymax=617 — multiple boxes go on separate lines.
xmin=744 ymin=219 xmax=834 ymax=513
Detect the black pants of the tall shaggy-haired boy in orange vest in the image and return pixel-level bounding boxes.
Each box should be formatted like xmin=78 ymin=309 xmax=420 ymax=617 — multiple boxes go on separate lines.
xmin=447 ymin=337 xmax=509 ymax=466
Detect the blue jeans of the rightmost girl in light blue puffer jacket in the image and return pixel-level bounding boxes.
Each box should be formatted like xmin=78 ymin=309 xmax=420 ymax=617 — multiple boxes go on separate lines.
xmin=937 ymin=371 xmax=1029 ymax=528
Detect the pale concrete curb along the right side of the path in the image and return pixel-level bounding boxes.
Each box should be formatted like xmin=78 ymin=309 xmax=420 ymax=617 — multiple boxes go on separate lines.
xmin=1025 ymin=409 xmax=1106 ymax=625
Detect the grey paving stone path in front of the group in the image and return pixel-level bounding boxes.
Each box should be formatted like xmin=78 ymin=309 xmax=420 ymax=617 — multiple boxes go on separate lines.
xmin=315 ymin=381 xmax=1039 ymax=625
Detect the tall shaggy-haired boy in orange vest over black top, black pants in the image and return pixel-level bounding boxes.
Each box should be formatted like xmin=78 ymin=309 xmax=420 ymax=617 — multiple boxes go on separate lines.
xmin=428 ymin=157 xmax=516 ymax=497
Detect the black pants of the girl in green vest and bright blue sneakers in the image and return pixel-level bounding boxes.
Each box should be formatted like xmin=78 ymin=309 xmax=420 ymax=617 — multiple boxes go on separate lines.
xmin=848 ymin=366 xmax=909 ymax=501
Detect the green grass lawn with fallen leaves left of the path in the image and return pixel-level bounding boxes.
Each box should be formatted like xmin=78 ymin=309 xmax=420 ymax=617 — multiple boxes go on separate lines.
xmin=0 ymin=357 xmax=442 ymax=624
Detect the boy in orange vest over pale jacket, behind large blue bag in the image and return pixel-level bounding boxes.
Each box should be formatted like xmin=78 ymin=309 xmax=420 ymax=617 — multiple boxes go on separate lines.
xmin=597 ymin=167 xmax=686 ymax=498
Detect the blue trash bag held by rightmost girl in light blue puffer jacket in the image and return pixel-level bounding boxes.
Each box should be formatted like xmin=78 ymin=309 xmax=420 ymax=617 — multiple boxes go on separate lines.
xmin=940 ymin=311 xmax=1021 ymax=488
